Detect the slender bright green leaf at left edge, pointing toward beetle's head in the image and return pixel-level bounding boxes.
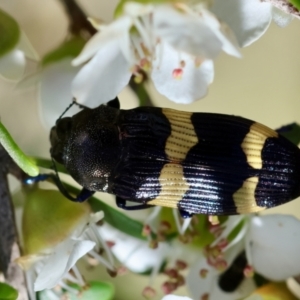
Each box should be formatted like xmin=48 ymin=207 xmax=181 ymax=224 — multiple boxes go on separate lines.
xmin=0 ymin=122 xmax=39 ymax=176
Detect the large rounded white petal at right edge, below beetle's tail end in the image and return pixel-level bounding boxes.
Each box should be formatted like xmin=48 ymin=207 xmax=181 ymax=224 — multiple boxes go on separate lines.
xmin=247 ymin=215 xmax=300 ymax=281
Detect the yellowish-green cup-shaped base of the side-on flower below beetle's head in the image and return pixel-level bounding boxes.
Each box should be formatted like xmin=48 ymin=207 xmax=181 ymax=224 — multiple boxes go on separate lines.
xmin=22 ymin=186 xmax=90 ymax=254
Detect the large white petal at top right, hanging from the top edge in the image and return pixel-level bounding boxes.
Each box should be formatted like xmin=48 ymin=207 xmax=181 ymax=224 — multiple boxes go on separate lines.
xmin=212 ymin=0 xmax=272 ymax=47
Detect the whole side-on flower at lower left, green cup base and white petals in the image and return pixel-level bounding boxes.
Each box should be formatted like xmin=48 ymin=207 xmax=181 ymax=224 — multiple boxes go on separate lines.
xmin=18 ymin=188 xmax=116 ymax=300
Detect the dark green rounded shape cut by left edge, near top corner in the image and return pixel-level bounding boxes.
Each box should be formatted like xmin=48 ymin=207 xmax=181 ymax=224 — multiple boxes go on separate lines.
xmin=0 ymin=9 xmax=20 ymax=57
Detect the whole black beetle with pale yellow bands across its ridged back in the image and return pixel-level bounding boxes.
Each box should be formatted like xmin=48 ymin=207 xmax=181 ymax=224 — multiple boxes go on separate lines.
xmin=50 ymin=98 xmax=300 ymax=217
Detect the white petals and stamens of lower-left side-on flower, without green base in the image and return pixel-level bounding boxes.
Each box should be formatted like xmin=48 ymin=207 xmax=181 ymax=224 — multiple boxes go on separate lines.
xmin=18 ymin=212 xmax=115 ymax=299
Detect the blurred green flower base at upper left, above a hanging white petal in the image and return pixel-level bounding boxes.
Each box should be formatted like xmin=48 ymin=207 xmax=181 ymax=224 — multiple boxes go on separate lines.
xmin=42 ymin=37 xmax=85 ymax=66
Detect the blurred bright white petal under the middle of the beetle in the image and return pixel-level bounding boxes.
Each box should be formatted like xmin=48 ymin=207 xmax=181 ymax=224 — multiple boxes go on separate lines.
xmin=99 ymin=224 xmax=170 ymax=273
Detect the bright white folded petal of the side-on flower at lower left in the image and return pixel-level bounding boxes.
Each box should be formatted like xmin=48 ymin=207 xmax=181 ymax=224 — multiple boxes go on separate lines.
xmin=34 ymin=239 xmax=95 ymax=291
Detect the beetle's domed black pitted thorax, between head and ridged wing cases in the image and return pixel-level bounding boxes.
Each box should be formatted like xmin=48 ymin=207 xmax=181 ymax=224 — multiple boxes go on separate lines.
xmin=63 ymin=118 xmax=120 ymax=192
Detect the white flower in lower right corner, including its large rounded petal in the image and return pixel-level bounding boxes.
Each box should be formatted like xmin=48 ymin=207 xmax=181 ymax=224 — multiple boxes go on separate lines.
xmin=187 ymin=215 xmax=300 ymax=300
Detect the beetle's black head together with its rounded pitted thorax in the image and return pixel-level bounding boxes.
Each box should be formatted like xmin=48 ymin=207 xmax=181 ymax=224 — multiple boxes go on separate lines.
xmin=50 ymin=105 xmax=121 ymax=191
